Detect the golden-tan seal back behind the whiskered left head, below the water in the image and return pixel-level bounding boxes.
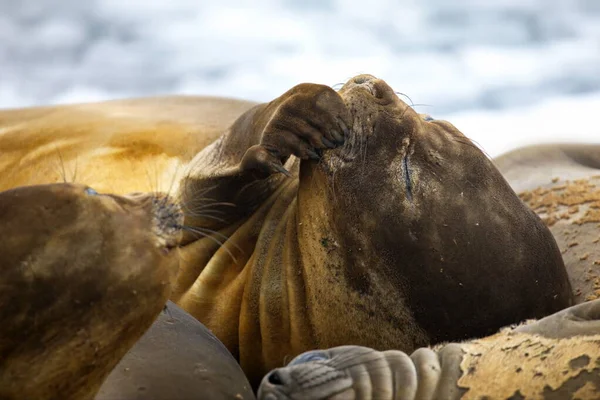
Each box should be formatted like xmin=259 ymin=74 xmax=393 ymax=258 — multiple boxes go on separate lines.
xmin=0 ymin=97 xmax=253 ymax=194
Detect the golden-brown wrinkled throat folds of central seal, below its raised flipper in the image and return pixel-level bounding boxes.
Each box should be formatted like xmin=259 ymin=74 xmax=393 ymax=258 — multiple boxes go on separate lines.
xmin=173 ymin=152 xmax=428 ymax=385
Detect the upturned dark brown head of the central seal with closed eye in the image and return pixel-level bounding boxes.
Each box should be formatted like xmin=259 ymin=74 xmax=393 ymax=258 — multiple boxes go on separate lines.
xmin=298 ymin=75 xmax=572 ymax=351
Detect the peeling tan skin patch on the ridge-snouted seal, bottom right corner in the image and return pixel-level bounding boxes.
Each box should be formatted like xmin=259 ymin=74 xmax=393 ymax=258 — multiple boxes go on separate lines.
xmin=458 ymin=333 xmax=600 ymax=400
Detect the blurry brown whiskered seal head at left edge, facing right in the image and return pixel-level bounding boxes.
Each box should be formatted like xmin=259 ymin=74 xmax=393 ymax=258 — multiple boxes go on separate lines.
xmin=0 ymin=184 xmax=182 ymax=399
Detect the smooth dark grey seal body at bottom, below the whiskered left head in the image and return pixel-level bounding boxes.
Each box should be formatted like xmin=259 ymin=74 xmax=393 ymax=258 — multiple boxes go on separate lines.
xmin=95 ymin=301 xmax=255 ymax=400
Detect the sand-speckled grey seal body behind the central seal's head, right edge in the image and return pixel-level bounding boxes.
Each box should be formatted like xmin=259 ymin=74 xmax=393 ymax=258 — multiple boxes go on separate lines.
xmin=495 ymin=143 xmax=600 ymax=303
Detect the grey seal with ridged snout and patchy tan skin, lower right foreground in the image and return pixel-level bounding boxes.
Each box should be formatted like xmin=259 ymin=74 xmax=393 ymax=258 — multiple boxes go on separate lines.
xmin=258 ymin=300 xmax=600 ymax=400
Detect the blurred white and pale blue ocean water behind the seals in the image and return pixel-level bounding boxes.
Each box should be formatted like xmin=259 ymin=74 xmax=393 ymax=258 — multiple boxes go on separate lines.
xmin=0 ymin=0 xmax=600 ymax=156
